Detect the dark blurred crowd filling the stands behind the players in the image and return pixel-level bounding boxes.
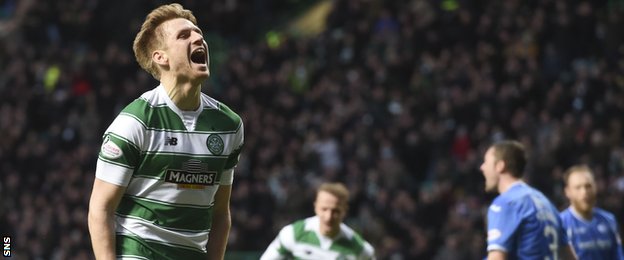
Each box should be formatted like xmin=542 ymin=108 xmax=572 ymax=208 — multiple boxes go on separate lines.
xmin=0 ymin=0 xmax=624 ymax=259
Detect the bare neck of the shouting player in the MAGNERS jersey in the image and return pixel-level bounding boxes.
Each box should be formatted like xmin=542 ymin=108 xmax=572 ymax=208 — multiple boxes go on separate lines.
xmin=161 ymin=78 xmax=201 ymax=111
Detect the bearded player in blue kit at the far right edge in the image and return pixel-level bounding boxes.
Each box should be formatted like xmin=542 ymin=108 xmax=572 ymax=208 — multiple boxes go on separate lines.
xmin=560 ymin=165 xmax=624 ymax=260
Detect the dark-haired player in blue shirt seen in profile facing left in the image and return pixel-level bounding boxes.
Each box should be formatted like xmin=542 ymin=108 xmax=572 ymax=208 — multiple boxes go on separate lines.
xmin=481 ymin=141 xmax=576 ymax=260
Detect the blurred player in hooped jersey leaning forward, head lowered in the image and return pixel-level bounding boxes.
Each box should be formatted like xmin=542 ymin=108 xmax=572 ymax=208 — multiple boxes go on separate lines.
xmin=260 ymin=183 xmax=375 ymax=260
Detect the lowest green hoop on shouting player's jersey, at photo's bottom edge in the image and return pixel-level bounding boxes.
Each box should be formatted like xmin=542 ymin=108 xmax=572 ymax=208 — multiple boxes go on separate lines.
xmin=115 ymin=234 xmax=207 ymax=259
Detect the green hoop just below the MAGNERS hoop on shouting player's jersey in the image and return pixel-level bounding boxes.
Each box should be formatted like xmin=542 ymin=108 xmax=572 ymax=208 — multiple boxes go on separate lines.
xmin=117 ymin=195 xmax=212 ymax=232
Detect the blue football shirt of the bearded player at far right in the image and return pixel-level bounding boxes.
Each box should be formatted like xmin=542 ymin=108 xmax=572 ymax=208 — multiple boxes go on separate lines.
xmin=560 ymin=207 xmax=624 ymax=260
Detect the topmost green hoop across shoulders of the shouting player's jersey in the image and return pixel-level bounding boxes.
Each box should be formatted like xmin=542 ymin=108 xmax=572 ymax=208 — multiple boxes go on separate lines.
xmin=121 ymin=98 xmax=241 ymax=132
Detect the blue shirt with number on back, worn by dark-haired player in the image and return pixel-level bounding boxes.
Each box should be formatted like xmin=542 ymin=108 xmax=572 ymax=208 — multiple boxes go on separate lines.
xmin=487 ymin=182 xmax=568 ymax=260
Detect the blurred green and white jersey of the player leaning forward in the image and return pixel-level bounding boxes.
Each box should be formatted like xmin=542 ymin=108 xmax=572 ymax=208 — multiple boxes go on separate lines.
xmin=260 ymin=216 xmax=376 ymax=260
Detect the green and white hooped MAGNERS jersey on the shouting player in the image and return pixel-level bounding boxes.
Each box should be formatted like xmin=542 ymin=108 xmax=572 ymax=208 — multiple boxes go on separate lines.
xmin=96 ymin=85 xmax=243 ymax=259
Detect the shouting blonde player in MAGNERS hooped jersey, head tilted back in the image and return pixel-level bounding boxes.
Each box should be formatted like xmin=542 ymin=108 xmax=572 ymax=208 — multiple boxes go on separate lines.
xmin=88 ymin=4 xmax=243 ymax=259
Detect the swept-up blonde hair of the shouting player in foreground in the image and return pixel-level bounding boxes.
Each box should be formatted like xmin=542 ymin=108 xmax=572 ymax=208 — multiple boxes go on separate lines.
xmin=132 ymin=3 xmax=197 ymax=80
